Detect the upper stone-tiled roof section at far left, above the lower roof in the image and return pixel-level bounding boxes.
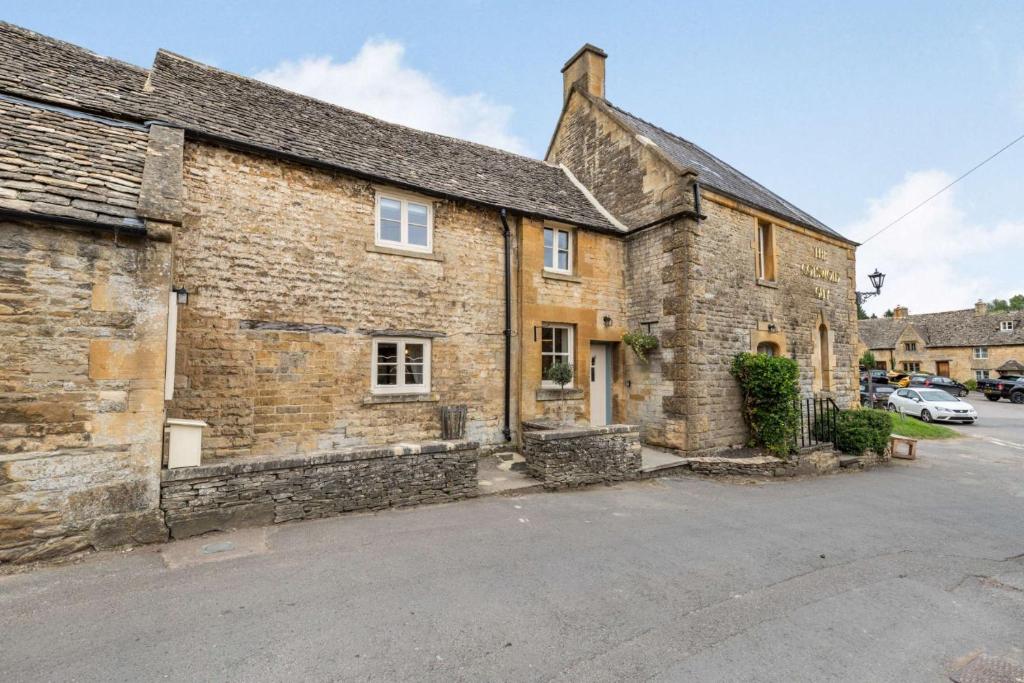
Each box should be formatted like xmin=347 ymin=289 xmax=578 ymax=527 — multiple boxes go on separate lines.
xmin=0 ymin=22 xmax=146 ymax=117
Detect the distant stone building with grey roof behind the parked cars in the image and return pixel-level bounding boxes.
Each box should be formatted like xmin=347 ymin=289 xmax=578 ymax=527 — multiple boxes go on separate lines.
xmin=858 ymin=301 xmax=1024 ymax=382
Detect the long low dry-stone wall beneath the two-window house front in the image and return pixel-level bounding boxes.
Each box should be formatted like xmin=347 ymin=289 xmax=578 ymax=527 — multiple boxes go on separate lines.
xmin=161 ymin=441 xmax=479 ymax=539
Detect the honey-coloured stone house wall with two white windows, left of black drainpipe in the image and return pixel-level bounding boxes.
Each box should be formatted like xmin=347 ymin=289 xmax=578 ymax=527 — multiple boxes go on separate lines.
xmin=169 ymin=143 xmax=514 ymax=459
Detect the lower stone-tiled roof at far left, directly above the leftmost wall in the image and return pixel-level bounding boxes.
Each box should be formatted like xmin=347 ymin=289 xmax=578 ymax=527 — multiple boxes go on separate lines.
xmin=0 ymin=96 xmax=148 ymax=225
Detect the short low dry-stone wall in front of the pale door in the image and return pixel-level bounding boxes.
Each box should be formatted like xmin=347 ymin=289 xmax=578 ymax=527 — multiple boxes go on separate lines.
xmin=522 ymin=425 xmax=641 ymax=488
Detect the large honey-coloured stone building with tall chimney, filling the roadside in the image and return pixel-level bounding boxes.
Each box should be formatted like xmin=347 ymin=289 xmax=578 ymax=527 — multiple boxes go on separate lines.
xmin=0 ymin=24 xmax=857 ymax=562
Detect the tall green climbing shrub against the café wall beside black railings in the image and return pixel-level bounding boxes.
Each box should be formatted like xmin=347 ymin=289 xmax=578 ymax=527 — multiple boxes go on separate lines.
xmin=730 ymin=353 xmax=800 ymax=458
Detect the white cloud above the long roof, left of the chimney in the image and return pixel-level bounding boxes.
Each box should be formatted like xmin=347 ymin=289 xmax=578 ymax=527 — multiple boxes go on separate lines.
xmin=256 ymin=40 xmax=528 ymax=154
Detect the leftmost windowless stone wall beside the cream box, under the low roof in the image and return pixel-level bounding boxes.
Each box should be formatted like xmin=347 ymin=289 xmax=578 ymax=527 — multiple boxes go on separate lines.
xmin=0 ymin=222 xmax=170 ymax=563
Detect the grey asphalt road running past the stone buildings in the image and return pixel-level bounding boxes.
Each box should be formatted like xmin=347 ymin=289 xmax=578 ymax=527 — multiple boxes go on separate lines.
xmin=0 ymin=423 xmax=1024 ymax=682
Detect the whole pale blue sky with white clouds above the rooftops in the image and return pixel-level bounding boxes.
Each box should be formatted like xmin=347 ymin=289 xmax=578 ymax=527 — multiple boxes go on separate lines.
xmin=9 ymin=0 xmax=1024 ymax=312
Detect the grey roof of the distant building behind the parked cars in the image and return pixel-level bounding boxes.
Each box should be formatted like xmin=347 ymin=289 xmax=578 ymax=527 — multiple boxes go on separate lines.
xmin=857 ymin=308 xmax=1024 ymax=349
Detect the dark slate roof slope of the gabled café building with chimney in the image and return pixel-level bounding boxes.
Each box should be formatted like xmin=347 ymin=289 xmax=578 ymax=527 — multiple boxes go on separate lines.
xmin=602 ymin=100 xmax=850 ymax=242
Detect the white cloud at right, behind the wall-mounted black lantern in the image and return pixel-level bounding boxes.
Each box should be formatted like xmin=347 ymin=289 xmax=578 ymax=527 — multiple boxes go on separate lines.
xmin=844 ymin=170 xmax=1024 ymax=315
